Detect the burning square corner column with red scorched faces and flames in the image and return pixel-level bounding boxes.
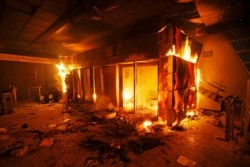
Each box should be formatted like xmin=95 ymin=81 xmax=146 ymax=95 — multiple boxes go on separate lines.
xmin=158 ymin=25 xmax=202 ymax=126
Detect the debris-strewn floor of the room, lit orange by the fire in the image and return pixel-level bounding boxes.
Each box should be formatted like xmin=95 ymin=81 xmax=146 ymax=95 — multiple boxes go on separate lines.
xmin=0 ymin=102 xmax=250 ymax=167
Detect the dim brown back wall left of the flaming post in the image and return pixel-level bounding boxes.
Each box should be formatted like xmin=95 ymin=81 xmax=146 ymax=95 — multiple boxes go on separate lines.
xmin=0 ymin=61 xmax=60 ymax=99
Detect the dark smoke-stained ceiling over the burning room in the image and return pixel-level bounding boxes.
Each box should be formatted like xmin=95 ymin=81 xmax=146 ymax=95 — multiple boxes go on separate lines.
xmin=0 ymin=0 xmax=250 ymax=61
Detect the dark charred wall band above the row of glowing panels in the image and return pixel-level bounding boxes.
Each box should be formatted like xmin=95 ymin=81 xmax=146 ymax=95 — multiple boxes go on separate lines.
xmin=76 ymin=34 xmax=159 ymax=67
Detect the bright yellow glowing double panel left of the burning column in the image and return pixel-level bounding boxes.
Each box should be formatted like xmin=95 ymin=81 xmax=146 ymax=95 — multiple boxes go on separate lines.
xmin=120 ymin=61 xmax=158 ymax=115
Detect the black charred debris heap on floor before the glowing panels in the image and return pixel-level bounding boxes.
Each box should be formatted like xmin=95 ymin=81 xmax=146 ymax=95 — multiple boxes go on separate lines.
xmin=78 ymin=112 xmax=172 ymax=166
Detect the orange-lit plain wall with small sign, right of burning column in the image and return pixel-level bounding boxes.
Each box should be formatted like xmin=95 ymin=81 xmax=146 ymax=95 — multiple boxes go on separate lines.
xmin=197 ymin=34 xmax=249 ymax=100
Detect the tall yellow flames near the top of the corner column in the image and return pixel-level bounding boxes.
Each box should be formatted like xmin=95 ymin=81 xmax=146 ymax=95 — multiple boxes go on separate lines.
xmin=166 ymin=37 xmax=198 ymax=63
